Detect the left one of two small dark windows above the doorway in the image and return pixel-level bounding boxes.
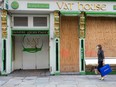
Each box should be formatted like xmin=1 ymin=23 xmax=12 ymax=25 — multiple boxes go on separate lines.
xmin=14 ymin=17 xmax=28 ymax=27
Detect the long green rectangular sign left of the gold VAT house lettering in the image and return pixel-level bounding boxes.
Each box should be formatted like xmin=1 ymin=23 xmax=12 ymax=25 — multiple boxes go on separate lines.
xmin=27 ymin=3 xmax=49 ymax=9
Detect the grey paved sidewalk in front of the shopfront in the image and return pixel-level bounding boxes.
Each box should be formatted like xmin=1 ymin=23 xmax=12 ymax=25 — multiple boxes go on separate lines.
xmin=0 ymin=75 xmax=116 ymax=87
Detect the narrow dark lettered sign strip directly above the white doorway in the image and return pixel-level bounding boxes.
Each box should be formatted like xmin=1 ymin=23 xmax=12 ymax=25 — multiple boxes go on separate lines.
xmin=12 ymin=30 xmax=49 ymax=35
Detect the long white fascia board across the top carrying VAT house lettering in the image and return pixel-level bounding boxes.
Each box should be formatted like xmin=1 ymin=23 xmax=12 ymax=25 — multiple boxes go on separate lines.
xmin=8 ymin=0 xmax=115 ymax=12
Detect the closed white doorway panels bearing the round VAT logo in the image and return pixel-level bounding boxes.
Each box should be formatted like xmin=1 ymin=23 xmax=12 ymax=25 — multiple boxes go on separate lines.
xmin=12 ymin=35 xmax=49 ymax=70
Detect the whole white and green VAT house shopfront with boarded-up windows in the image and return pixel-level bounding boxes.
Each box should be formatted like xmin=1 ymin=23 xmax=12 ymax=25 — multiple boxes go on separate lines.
xmin=0 ymin=0 xmax=116 ymax=74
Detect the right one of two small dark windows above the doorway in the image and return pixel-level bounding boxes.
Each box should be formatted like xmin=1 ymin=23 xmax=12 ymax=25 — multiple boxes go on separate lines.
xmin=33 ymin=17 xmax=47 ymax=27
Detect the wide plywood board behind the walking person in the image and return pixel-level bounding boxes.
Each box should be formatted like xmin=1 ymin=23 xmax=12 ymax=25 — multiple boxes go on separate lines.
xmin=85 ymin=17 xmax=116 ymax=57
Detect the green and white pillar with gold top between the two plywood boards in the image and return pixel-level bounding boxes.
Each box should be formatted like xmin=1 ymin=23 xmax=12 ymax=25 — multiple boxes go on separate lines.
xmin=79 ymin=12 xmax=86 ymax=74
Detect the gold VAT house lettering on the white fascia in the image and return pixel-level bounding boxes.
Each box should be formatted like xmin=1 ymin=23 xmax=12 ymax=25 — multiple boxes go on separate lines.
xmin=56 ymin=2 xmax=106 ymax=11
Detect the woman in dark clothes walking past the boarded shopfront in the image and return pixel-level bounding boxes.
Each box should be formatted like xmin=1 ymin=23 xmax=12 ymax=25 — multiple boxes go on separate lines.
xmin=97 ymin=44 xmax=104 ymax=80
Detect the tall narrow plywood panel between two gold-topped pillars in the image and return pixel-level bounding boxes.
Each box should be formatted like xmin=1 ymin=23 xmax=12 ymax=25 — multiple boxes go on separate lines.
xmin=60 ymin=17 xmax=79 ymax=72
